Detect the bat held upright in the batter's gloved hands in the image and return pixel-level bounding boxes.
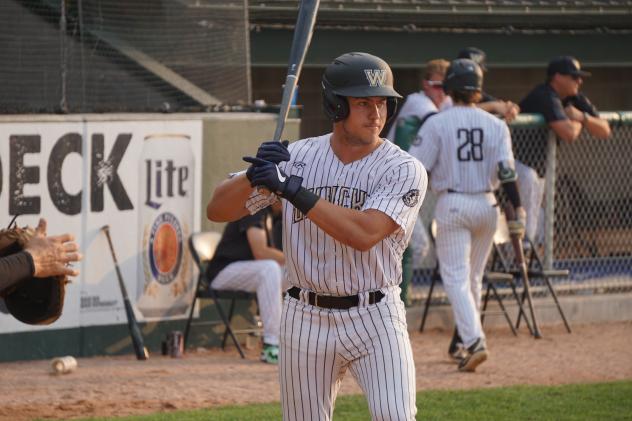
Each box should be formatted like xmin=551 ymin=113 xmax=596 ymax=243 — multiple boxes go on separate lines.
xmin=273 ymin=0 xmax=320 ymax=141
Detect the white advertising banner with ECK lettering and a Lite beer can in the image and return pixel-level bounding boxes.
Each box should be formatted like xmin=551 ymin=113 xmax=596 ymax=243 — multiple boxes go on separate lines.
xmin=0 ymin=119 xmax=202 ymax=333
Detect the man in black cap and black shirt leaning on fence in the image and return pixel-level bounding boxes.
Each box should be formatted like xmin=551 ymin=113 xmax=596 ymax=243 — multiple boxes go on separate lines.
xmin=514 ymin=56 xmax=610 ymax=241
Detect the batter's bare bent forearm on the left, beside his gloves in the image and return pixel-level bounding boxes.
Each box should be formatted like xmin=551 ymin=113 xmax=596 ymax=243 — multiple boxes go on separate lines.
xmin=206 ymin=174 xmax=252 ymax=222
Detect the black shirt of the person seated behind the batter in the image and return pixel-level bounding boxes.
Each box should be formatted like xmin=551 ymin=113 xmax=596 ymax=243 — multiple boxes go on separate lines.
xmin=206 ymin=209 xmax=268 ymax=280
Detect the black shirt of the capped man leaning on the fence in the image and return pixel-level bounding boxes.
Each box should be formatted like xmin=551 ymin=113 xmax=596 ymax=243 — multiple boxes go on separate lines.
xmin=513 ymin=83 xmax=599 ymax=176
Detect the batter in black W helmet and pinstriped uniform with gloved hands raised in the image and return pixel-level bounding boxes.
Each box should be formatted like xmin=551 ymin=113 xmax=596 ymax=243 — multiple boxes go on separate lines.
xmin=207 ymin=53 xmax=427 ymax=420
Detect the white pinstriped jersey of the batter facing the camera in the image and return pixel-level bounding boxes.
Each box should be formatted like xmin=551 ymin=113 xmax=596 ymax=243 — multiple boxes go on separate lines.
xmin=246 ymin=133 xmax=428 ymax=296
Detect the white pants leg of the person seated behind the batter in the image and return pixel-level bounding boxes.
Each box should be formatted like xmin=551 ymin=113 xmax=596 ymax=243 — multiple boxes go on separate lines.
xmin=212 ymin=260 xmax=283 ymax=345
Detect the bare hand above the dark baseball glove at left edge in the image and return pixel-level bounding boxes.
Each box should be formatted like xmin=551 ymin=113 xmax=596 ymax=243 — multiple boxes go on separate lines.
xmin=24 ymin=219 xmax=83 ymax=278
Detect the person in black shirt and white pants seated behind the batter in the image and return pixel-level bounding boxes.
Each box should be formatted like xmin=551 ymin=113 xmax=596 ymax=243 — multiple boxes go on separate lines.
xmin=207 ymin=202 xmax=285 ymax=364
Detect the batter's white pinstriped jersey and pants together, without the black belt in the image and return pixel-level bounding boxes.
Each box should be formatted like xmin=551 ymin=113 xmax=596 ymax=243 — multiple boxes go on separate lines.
xmin=246 ymin=134 xmax=428 ymax=421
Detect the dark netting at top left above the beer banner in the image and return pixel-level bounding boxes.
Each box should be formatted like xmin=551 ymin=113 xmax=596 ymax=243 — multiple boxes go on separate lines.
xmin=0 ymin=0 xmax=251 ymax=113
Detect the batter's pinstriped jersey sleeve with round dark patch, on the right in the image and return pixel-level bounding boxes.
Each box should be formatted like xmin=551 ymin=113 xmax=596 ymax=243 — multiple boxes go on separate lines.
xmin=362 ymin=158 xmax=428 ymax=233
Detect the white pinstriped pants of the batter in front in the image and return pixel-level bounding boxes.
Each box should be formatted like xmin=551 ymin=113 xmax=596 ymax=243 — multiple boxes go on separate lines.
xmin=279 ymin=288 xmax=417 ymax=421
